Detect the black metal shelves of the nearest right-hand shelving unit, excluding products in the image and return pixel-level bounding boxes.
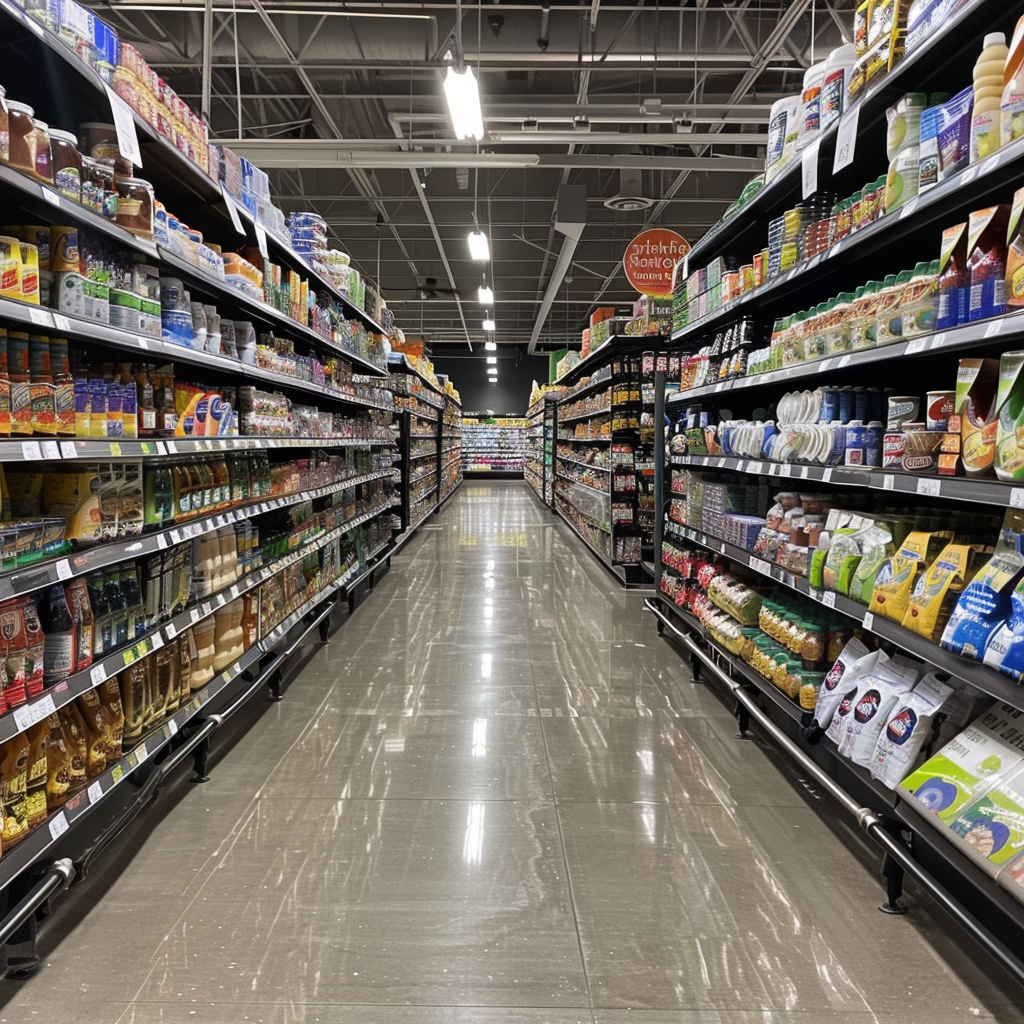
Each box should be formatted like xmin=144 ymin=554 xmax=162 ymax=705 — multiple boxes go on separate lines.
xmin=647 ymin=0 xmax=1024 ymax=978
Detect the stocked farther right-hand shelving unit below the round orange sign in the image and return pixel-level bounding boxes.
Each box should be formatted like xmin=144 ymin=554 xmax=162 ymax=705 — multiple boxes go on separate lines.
xmin=554 ymin=338 xmax=656 ymax=588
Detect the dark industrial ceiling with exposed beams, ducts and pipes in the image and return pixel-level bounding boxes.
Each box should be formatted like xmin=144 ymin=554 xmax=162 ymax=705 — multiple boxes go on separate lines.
xmin=90 ymin=0 xmax=856 ymax=354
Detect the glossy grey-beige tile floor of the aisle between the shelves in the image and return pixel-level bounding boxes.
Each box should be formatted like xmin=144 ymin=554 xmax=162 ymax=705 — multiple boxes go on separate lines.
xmin=0 ymin=482 xmax=1024 ymax=1024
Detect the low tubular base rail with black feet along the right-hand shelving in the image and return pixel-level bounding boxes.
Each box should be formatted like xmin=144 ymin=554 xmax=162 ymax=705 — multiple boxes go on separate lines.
xmin=644 ymin=598 xmax=1024 ymax=985
